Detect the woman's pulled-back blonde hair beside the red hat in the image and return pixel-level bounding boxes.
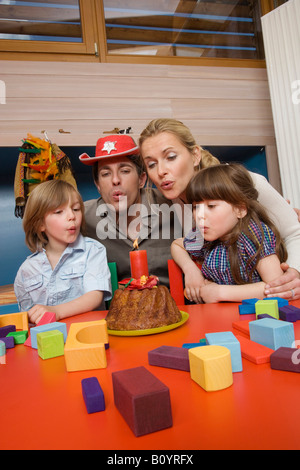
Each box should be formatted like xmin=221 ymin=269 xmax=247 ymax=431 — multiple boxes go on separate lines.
xmin=139 ymin=118 xmax=220 ymax=170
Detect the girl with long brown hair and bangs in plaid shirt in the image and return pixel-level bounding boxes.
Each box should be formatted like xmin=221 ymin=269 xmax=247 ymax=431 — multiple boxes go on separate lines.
xmin=172 ymin=164 xmax=286 ymax=302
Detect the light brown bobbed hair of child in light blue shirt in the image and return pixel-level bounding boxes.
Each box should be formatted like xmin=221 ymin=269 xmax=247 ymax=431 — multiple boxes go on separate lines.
xmin=23 ymin=180 xmax=85 ymax=252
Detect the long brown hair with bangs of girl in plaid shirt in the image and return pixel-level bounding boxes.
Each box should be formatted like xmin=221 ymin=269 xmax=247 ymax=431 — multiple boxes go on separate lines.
xmin=186 ymin=163 xmax=287 ymax=284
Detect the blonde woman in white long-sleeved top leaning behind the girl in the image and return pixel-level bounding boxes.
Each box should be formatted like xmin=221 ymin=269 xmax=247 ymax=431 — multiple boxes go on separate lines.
xmin=139 ymin=119 xmax=300 ymax=299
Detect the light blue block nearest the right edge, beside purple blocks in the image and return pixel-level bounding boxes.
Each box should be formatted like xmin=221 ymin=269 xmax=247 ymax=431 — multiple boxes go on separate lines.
xmin=249 ymin=318 xmax=295 ymax=350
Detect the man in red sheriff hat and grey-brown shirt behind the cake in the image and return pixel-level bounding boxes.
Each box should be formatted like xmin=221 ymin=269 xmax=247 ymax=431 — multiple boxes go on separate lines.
xmin=79 ymin=134 xmax=178 ymax=286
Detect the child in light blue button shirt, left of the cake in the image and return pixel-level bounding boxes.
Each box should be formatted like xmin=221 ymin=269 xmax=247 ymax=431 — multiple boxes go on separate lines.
xmin=14 ymin=180 xmax=111 ymax=323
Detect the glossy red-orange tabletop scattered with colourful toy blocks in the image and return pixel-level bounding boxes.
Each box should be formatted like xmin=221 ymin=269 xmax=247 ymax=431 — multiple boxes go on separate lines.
xmin=0 ymin=301 xmax=300 ymax=450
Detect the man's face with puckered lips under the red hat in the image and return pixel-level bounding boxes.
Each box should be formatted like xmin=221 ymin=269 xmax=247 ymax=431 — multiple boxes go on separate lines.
xmin=96 ymin=157 xmax=146 ymax=213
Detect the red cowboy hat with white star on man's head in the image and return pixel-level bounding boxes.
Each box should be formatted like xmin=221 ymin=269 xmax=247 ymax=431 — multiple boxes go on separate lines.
xmin=79 ymin=134 xmax=140 ymax=165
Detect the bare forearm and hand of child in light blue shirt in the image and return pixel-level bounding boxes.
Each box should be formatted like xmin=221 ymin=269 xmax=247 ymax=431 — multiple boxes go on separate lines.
xmin=28 ymin=291 xmax=103 ymax=323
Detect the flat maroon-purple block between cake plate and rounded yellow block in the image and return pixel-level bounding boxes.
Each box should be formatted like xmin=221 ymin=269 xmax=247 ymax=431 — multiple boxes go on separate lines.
xmin=148 ymin=346 xmax=190 ymax=372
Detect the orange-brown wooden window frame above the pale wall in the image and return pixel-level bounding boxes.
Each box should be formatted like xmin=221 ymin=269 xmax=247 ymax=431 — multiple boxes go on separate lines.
xmin=0 ymin=0 xmax=274 ymax=68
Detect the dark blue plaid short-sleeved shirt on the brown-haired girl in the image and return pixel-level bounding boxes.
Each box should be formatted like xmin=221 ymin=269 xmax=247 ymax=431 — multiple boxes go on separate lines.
xmin=184 ymin=221 xmax=276 ymax=285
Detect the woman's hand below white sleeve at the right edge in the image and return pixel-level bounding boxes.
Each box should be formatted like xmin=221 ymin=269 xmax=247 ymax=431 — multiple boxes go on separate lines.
xmin=265 ymin=263 xmax=300 ymax=300
